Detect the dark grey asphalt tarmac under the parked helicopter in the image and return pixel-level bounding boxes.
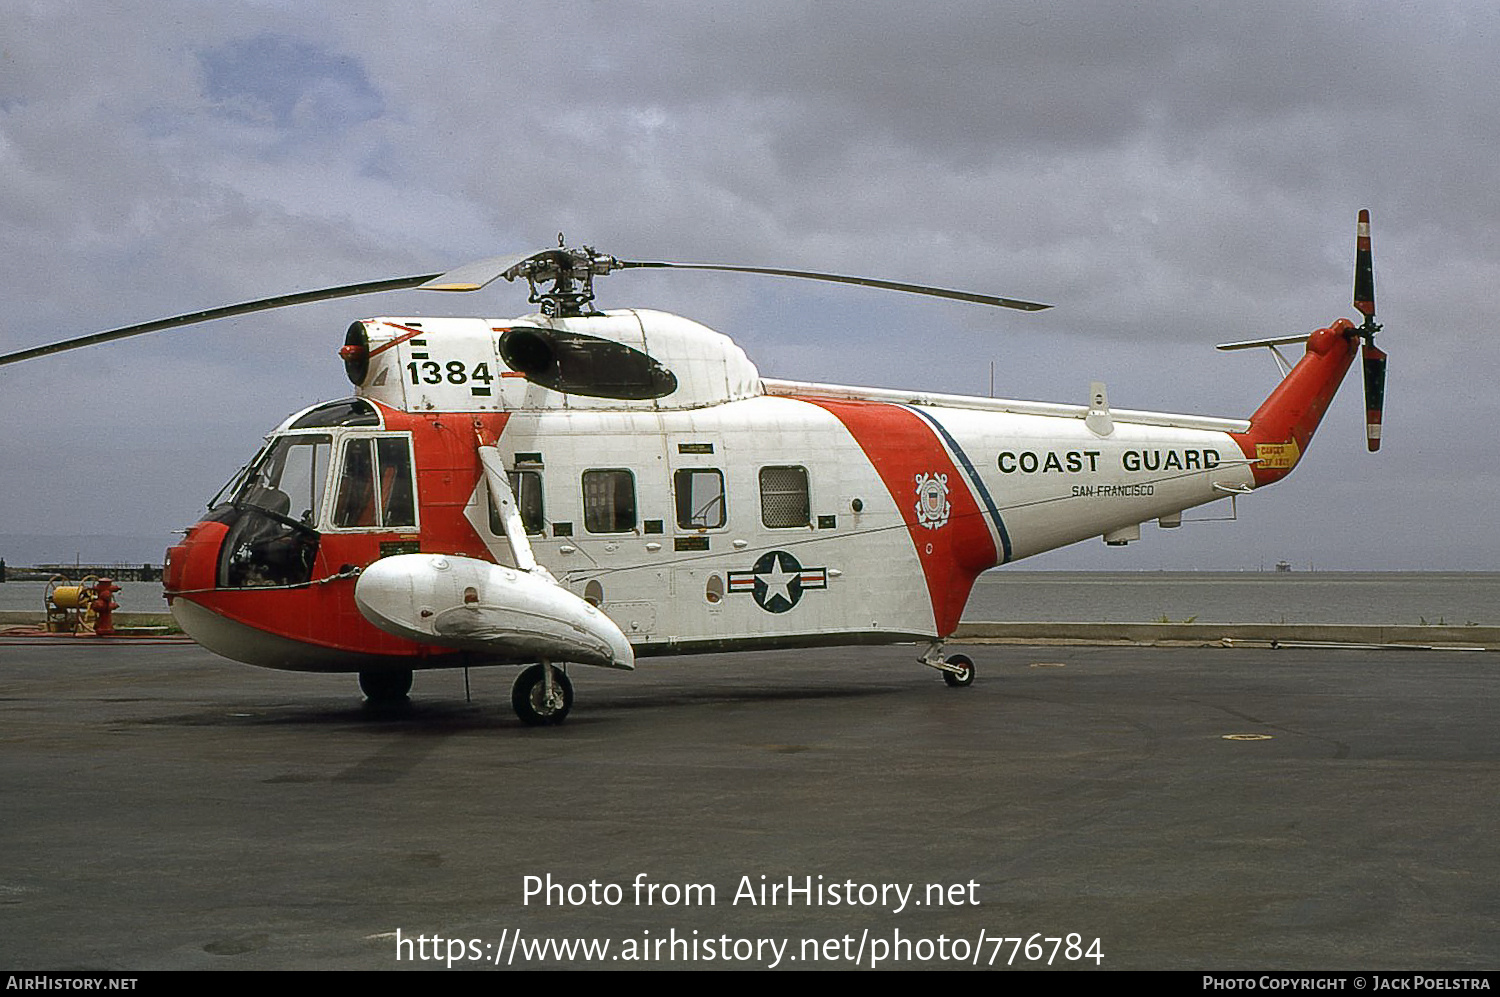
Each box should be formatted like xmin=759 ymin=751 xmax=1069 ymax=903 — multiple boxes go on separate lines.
xmin=0 ymin=640 xmax=1500 ymax=970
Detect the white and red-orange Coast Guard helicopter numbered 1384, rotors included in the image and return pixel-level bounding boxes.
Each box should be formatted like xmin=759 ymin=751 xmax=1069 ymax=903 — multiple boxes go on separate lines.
xmin=0 ymin=211 xmax=1386 ymax=724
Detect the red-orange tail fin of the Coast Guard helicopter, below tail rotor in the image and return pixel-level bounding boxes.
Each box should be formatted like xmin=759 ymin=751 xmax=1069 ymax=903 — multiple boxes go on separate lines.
xmin=1232 ymin=318 xmax=1359 ymax=487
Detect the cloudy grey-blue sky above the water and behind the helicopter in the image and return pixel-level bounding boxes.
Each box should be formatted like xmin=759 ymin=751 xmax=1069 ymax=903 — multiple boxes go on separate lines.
xmin=0 ymin=0 xmax=1500 ymax=570
